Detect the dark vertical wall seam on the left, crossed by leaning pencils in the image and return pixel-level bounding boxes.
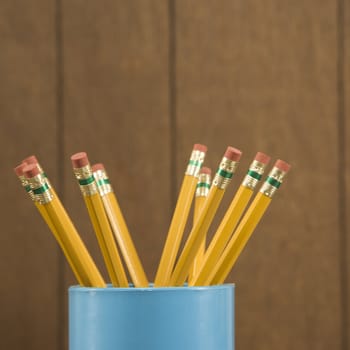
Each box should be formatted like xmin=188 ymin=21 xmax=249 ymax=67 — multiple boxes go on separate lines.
xmin=55 ymin=0 xmax=66 ymax=350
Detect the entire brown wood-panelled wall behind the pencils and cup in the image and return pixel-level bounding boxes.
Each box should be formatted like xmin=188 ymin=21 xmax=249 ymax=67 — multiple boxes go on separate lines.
xmin=0 ymin=0 xmax=350 ymax=350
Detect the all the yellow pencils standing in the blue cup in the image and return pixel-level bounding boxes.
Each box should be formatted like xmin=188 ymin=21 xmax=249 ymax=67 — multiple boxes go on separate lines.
xmin=15 ymin=144 xmax=290 ymax=288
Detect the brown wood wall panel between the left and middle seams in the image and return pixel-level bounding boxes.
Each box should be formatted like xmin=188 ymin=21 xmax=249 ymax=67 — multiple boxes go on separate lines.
xmin=63 ymin=0 xmax=170 ymax=348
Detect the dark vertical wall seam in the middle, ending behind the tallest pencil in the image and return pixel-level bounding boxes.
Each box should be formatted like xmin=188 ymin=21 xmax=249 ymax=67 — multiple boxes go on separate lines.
xmin=168 ymin=0 xmax=177 ymax=211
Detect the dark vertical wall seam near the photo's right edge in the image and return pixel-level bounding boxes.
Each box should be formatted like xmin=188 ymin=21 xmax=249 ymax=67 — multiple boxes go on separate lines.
xmin=337 ymin=0 xmax=349 ymax=350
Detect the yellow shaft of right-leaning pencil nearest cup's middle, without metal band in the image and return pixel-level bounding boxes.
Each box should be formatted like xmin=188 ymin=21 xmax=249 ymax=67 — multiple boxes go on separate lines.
xmin=154 ymin=175 xmax=198 ymax=287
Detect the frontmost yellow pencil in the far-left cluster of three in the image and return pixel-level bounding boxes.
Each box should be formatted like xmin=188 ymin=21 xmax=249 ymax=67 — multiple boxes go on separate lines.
xmin=23 ymin=164 xmax=106 ymax=287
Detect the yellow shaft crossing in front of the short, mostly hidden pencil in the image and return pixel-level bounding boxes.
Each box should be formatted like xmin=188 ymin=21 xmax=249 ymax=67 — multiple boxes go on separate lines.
xmin=170 ymin=186 xmax=225 ymax=286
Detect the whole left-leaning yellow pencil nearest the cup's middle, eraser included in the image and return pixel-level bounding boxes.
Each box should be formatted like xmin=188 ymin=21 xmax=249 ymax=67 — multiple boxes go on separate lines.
xmin=92 ymin=164 xmax=148 ymax=287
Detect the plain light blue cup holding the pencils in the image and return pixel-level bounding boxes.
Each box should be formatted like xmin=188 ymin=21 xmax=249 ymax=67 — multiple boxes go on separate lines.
xmin=69 ymin=284 xmax=234 ymax=350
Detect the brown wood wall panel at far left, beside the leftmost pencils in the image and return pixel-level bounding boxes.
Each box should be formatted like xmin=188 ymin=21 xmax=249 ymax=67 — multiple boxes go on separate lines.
xmin=0 ymin=0 xmax=60 ymax=350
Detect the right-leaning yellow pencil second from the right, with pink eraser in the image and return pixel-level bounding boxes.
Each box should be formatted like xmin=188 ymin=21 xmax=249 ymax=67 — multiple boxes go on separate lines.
xmin=189 ymin=152 xmax=270 ymax=286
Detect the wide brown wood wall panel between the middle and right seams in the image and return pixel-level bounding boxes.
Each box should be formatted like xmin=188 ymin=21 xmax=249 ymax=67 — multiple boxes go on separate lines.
xmin=175 ymin=0 xmax=341 ymax=350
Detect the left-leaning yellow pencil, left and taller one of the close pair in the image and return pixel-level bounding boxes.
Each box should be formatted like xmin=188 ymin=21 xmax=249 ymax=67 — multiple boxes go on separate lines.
xmin=71 ymin=152 xmax=129 ymax=287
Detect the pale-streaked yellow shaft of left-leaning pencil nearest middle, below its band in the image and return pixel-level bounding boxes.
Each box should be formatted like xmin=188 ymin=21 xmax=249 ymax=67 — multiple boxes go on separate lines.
xmin=101 ymin=192 xmax=149 ymax=287
